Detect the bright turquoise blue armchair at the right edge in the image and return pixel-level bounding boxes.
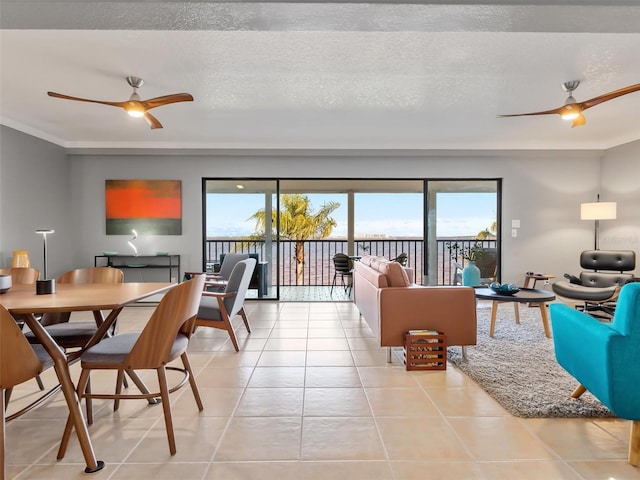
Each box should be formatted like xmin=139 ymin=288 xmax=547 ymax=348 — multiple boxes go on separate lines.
xmin=550 ymin=283 xmax=640 ymax=465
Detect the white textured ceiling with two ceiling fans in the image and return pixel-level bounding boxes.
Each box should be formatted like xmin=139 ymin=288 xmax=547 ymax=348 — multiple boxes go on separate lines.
xmin=0 ymin=0 xmax=640 ymax=149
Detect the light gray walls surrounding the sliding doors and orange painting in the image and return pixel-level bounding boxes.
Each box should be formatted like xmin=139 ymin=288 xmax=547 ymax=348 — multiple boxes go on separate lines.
xmin=0 ymin=127 xmax=640 ymax=283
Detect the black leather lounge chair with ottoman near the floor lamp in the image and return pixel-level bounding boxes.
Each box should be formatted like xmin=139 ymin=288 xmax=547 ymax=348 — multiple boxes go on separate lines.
xmin=552 ymin=250 xmax=636 ymax=319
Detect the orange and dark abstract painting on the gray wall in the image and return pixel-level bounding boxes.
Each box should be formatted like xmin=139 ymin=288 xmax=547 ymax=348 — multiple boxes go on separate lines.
xmin=105 ymin=180 xmax=182 ymax=235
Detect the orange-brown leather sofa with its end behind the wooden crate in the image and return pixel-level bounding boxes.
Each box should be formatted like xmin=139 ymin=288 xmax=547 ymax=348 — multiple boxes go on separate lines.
xmin=353 ymin=256 xmax=477 ymax=359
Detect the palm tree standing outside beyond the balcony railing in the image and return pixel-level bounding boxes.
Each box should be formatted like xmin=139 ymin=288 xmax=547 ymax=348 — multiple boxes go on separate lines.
xmin=250 ymin=193 xmax=340 ymax=285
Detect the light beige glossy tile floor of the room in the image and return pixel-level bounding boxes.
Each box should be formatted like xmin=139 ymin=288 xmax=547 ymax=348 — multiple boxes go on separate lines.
xmin=7 ymin=302 xmax=640 ymax=480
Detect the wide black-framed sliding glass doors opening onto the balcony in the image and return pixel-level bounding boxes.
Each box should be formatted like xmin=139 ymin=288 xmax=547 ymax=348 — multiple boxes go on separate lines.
xmin=203 ymin=179 xmax=500 ymax=301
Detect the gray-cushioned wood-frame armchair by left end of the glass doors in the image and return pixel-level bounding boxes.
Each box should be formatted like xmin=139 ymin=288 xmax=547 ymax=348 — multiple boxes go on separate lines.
xmin=195 ymin=258 xmax=256 ymax=352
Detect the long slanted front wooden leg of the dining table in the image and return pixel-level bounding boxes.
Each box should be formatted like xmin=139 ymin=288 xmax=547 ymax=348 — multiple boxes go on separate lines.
xmin=24 ymin=315 xmax=104 ymax=473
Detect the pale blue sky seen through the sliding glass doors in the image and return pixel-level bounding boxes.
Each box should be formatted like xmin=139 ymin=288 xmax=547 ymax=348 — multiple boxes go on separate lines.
xmin=207 ymin=193 xmax=496 ymax=237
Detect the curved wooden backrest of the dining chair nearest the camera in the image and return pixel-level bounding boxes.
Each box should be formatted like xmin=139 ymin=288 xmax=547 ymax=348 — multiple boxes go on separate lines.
xmin=126 ymin=275 xmax=205 ymax=370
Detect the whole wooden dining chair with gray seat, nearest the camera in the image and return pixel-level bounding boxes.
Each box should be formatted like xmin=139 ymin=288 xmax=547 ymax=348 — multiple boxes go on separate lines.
xmin=58 ymin=275 xmax=205 ymax=458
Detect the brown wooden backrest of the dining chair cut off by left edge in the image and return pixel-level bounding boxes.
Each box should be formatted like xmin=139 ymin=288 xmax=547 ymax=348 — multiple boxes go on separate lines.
xmin=0 ymin=305 xmax=42 ymax=390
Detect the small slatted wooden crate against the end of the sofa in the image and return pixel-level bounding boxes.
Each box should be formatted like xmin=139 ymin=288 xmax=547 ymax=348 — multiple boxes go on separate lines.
xmin=404 ymin=330 xmax=447 ymax=370
